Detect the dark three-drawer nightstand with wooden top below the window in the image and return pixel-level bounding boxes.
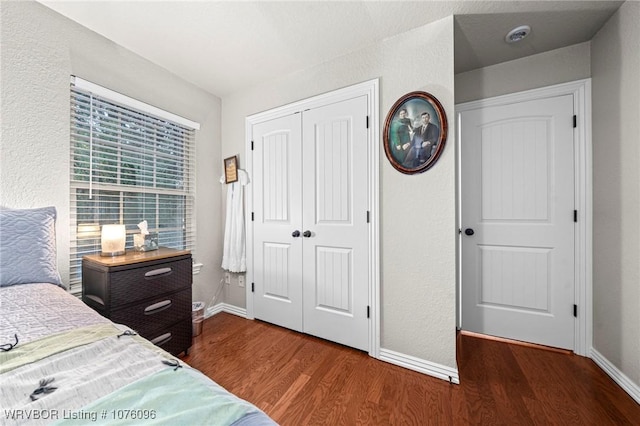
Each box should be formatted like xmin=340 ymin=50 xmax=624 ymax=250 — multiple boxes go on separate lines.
xmin=82 ymin=247 xmax=192 ymax=355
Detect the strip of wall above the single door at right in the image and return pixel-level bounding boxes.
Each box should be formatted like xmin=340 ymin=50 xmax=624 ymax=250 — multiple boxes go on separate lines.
xmin=455 ymin=42 xmax=591 ymax=103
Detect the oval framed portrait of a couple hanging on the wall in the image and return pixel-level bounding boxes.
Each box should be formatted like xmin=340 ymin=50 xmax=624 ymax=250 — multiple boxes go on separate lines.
xmin=383 ymin=92 xmax=447 ymax=174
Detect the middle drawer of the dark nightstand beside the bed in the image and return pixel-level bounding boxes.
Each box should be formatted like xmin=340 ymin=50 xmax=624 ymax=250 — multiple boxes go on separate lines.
xmin=111 ymin=288 xmax=191 ymax=338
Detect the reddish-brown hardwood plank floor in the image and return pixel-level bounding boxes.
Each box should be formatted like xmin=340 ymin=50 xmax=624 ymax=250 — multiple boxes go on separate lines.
xmin=183 ymin=313 xmax=640 ymax=426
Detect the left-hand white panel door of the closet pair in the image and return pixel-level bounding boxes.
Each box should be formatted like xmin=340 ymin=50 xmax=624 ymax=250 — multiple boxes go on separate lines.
xmin=251 ymin=114 xmax=302 ymax=331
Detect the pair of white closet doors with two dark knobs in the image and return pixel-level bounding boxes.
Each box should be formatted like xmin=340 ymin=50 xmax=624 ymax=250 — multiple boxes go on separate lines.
xmin=251 ymin=96 xmax=371 ymax=350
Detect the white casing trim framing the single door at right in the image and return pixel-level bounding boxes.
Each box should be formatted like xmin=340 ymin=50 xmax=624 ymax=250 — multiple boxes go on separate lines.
xmin=456 ymin=78 xmax=593 ymax=357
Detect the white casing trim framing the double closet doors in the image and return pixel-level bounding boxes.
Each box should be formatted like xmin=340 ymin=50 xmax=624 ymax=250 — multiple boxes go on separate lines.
xmin=245 ymin=78 xmax=380 ymax=358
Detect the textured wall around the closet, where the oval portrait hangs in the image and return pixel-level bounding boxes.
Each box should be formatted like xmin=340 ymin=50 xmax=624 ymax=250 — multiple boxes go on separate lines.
xmin=222 ymin=17 xmax=457 ymax=368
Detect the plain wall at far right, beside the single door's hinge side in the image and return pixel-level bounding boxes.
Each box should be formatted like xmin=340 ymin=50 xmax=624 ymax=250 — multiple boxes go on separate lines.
xmin=591 ymin=1 xmax=640 ymax=397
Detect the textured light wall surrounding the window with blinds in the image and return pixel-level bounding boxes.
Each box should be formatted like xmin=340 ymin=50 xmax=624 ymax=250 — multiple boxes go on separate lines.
xmin=0 ymin=1 xmax=222 ymax=310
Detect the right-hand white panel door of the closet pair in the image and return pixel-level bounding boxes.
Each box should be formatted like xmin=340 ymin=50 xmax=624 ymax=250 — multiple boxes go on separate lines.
xmin=302 ymin=96 xmax=369 ymax=350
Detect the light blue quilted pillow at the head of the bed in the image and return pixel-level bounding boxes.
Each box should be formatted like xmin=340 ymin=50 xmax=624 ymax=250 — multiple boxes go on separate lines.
xmin=0 ymin=207 xmax=62 ymax=287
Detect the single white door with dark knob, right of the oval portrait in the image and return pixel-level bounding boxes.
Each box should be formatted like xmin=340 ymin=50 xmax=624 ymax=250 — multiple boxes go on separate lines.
xmin=459 ymin=95 xmax=575 ymax=349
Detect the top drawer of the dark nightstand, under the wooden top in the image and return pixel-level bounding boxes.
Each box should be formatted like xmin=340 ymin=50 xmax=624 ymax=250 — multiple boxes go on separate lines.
xmin=109 ymin=258 xmax=192 ymax=307
